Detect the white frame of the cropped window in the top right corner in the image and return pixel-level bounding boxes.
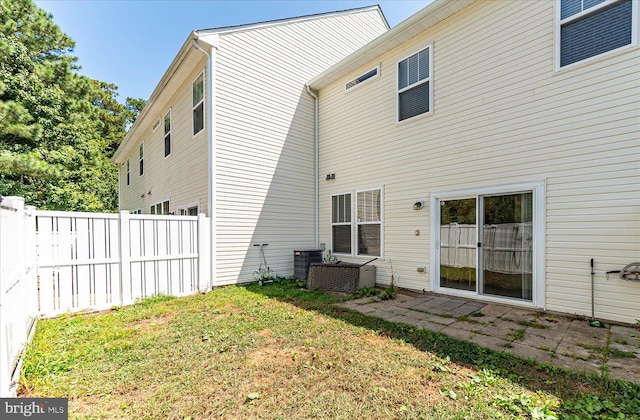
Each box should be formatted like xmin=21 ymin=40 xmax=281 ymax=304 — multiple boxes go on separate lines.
xmin=554 ymin=0 xmax=640 ymax=72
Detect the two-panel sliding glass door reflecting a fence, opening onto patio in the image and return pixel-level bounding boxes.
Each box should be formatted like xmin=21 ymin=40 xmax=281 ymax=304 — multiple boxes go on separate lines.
xmin=436 ymin=191 xmax=535 ymax=301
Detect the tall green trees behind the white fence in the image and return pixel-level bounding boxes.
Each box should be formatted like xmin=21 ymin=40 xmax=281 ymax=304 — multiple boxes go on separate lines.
xmin=0 ymin=0 xmax=144 ymax=211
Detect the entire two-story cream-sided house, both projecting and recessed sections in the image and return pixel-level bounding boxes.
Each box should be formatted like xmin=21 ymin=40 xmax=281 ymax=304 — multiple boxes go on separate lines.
xmin=114 ymin=0 xmax=640 ymax=323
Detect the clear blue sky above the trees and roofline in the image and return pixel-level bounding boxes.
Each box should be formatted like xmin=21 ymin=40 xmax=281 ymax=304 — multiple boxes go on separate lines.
xmin=35 ymin=0 xmax=430 ymax=102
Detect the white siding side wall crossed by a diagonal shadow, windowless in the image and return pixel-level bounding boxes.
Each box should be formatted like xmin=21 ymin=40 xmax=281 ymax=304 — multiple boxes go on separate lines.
xmin=215 ymin=10 xmax=387 ymax=285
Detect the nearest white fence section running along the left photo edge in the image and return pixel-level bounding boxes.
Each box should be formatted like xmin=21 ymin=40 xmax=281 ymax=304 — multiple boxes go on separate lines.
xmin=0 ymin=197 xmax=38 ymax=397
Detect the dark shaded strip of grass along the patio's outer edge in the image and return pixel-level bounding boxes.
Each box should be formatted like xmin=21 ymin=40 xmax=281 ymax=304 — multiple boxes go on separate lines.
xmin=245 ymin=282 xmax=640 ymax=419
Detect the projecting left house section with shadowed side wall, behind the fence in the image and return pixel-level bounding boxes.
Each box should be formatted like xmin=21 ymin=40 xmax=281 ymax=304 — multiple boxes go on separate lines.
xmin=113 ymin=6 xmax=388 ymax=285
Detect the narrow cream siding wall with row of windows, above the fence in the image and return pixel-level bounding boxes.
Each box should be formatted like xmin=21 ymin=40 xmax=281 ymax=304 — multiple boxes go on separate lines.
xmin=120 ymin=56 xmax=208 ymax=214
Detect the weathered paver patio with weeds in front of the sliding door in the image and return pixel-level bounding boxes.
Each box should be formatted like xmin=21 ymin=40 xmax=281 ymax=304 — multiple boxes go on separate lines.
xmin=337 ymin=294 xmax=640 ymax=384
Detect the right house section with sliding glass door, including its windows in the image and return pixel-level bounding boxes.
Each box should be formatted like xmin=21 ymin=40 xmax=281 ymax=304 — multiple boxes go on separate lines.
xmin=309 ymin=0 xmax=640 ymax=323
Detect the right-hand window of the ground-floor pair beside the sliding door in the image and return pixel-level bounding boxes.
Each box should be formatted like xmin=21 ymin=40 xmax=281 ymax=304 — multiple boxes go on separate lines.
xmin=356 ymin=188 xmax=382 ymax=257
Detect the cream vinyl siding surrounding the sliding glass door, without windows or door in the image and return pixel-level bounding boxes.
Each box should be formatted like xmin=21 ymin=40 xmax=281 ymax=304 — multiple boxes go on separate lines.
xmin=320 ymin=1 xmax=640 ymax=323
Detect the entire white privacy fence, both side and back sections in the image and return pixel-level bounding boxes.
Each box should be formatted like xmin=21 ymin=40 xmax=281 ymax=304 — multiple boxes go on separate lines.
xmin=0 ymin=198 xmax=211 ymax=397
